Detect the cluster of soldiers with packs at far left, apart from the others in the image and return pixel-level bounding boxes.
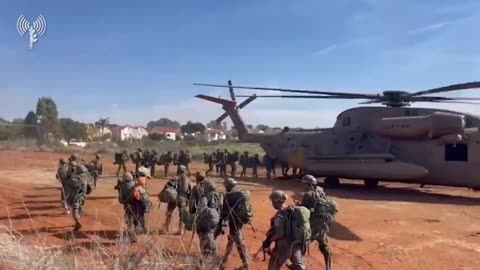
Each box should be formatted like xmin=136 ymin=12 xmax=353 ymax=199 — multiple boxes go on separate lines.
xmin=56 ymin=154 xmax=103 ymax=231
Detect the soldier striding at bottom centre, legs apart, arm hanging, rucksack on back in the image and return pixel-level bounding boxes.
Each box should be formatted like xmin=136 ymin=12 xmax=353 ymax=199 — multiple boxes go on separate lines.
xmin=215 ymin=178 xmax=252 ymax=270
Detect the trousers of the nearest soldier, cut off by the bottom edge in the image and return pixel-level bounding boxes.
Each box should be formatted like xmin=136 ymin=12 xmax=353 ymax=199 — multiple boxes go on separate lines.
xmin=268 ymin=240 xmax=306 ymax=270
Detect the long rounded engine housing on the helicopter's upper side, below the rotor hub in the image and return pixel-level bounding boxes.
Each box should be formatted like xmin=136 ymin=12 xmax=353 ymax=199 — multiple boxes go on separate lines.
xmin=373 ymin=112 xmax=465 ymax=139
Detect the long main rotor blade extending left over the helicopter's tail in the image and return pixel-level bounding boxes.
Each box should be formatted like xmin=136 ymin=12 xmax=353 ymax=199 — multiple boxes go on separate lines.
xmin=193 ymin=83 xmax=380 ymax=99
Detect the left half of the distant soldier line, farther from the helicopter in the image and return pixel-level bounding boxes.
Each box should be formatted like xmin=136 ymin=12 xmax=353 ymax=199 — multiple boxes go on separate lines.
xmin=114 ymin=148 xmax=192 ymax=177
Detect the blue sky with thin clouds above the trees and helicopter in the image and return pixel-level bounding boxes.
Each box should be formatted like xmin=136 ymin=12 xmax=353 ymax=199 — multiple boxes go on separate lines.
xmin=0 ymin=0 xmax=480 ymax=127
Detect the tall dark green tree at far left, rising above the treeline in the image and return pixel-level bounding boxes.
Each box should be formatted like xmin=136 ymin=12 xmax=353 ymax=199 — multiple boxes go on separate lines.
xmin=37 ymin=97 xmax=58 ymax=142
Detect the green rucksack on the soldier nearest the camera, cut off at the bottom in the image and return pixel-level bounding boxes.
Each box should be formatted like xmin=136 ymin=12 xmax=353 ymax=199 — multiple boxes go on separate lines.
xmin=284 ymin=206 xmax=312 ymax=245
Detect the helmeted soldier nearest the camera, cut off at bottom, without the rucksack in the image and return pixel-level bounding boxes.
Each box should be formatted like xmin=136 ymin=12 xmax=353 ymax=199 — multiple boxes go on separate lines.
xmin=262 ymin=190 xmax=305 ymax=270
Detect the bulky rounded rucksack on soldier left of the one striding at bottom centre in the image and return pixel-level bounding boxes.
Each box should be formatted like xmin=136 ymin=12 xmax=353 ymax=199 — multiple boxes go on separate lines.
xmin=194 ymin=192 xmax=222 ymax=233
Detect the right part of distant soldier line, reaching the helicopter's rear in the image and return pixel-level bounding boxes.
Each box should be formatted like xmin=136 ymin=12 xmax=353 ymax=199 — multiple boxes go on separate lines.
xmin=203 ymin=149 xmax=302 ymax=179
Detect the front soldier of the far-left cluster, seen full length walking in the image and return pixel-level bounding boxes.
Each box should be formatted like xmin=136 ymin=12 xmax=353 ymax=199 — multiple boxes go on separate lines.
xmin=65 ymin=159 xmax=88 ymax=232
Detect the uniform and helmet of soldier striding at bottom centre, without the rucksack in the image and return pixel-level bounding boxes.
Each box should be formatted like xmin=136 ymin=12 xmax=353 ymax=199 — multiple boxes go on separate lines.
xmin=215 ymin=178 xmax=250 ymax=270
